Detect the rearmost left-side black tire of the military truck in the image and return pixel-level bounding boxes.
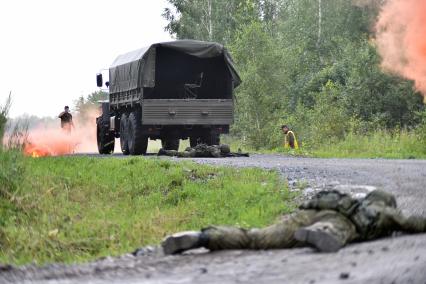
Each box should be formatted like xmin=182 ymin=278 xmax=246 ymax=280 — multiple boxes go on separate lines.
xmin=127 ymin=111 xmax=148 ymax=155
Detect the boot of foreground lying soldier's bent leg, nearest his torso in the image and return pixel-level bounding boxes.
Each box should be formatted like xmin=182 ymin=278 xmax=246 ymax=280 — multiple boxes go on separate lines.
xmin=294 ymin=222 xmax=345 ymax=252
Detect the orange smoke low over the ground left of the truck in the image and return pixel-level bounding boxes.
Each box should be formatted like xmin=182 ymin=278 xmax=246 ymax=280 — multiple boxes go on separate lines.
xmin=24 ymin=110 xmax=99 ymax=157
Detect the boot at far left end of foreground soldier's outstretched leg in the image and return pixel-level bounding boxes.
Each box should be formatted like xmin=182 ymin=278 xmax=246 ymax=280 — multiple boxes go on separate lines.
xmin=161 ymin=231 xmax=206 ymax=254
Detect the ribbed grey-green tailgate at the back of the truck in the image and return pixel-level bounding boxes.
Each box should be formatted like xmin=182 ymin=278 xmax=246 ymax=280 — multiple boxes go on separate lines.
xmin=142 ymin=99 xmax=234 ymax=125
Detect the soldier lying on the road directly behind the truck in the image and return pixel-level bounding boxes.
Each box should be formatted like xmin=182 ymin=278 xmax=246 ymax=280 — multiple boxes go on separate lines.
xmin=158 ymin=144 xmax=249 ymax=158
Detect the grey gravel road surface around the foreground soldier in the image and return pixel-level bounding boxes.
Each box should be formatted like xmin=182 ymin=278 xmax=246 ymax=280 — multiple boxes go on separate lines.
xmin=0 ymin=155 xmax=426 ymax=284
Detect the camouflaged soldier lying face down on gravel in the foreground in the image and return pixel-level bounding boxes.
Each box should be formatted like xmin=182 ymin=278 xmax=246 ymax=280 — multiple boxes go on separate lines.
xmin=161 ymin=190 xmax=426 ymax=254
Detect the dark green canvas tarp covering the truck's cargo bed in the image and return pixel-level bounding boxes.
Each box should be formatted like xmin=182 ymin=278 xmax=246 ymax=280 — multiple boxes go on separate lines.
xmin=109 ymin=40 xmax=241 ymax=93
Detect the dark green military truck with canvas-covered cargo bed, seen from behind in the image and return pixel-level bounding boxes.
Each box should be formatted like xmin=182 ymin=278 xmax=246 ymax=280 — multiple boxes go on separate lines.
xmin=96 ymin=40 xmax=241 ymax=155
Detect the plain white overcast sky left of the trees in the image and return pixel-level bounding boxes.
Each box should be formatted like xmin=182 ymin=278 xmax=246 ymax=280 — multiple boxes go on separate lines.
xmin=0 ymin=0 xmax=171 ymax=117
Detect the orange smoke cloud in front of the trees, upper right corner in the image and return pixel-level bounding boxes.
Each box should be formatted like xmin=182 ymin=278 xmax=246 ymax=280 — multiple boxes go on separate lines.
xmin=376 ymin=0 xmax=426 ymax=96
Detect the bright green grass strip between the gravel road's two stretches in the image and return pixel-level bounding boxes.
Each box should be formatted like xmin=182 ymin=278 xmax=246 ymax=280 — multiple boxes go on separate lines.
xmin=0 ymin=152 xmax=294 ymax=264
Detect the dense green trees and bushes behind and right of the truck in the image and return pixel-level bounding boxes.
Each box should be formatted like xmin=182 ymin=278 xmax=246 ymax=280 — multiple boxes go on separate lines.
xmin=164 ymin=0 xmax=426 ymax=153
